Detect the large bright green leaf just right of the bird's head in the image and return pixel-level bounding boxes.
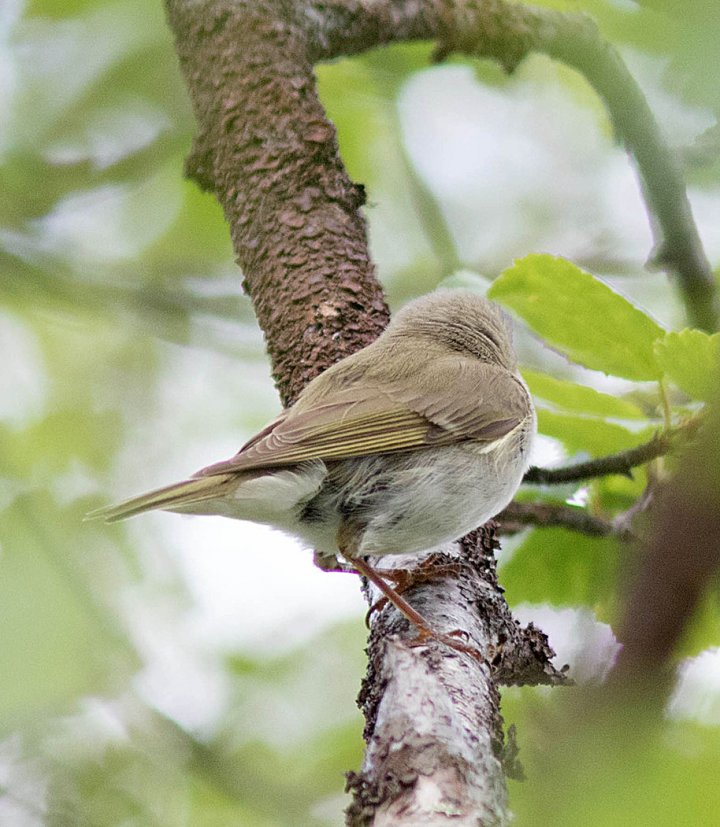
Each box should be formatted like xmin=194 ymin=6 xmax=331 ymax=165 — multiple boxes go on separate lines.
xmin=488 ymin=255 xmax=665 ymax=381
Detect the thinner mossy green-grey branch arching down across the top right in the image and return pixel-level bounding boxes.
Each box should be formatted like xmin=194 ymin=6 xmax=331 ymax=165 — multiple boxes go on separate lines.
xmin=300 ymin=0 xmax=719 ymax=331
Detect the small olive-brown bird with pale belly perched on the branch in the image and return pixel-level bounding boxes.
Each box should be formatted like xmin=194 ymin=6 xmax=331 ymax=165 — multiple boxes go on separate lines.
xmin=87 ymin=289 xmax=536 ymax=649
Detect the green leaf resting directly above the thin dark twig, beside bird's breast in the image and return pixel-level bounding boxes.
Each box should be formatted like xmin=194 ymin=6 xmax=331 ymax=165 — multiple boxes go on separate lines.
xmin=537 ymin=408 xmax=653 ymax=457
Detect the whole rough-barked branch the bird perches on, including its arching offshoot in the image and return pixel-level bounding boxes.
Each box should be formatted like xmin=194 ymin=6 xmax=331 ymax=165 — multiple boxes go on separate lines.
xmin=166 ymin=0 xmax=704 ymax=825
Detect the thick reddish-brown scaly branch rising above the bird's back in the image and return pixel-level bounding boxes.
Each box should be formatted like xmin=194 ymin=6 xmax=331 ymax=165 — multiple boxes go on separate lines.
xmin=167 ymin=0 xmax=388 ymax=403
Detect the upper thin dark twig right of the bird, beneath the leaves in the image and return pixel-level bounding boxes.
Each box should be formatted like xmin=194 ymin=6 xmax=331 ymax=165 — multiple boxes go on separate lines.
xmin=523 ymin=417 xmax=701 ymax=485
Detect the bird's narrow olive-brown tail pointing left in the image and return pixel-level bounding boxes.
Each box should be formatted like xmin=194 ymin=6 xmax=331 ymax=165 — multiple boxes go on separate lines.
xmin=85 ymin=474 xmax=232 ymax=523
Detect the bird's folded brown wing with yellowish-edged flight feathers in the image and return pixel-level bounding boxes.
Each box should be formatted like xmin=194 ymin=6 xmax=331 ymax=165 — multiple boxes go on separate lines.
xmin=197 ymin=356 xmax=529 ymax=476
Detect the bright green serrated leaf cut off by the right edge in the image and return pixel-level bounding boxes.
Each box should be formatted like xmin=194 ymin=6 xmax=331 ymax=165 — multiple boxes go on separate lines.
xmin=655 ymin=329 xmax=720 ymax=402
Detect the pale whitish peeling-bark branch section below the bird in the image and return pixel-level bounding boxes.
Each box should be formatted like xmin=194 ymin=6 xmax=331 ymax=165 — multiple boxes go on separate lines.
xmin=348 ymin=522 xmax=567 ymax=827
